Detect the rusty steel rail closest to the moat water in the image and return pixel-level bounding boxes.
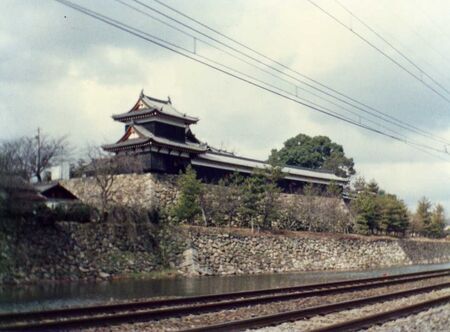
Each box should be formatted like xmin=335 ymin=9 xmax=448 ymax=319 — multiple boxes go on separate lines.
xmin=0 ymin=269 xmax=450 ymax=324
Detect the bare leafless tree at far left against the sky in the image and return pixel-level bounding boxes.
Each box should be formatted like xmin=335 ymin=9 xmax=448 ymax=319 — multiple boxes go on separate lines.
xmin=0 ymin=130 xmax=71 ymax=182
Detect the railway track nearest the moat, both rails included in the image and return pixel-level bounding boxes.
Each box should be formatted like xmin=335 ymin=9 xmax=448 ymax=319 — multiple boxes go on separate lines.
xmin=0 ymin=269 xmax=450 ymax=331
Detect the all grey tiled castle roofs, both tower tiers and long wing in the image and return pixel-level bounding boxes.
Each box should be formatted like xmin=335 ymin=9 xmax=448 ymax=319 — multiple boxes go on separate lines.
xmin=102 ymin=92 xmax=348 ymax=186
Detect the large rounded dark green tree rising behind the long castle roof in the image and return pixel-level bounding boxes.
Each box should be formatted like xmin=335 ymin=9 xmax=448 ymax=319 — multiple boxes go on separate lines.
xmin=269 ymin=134 xmax=355 ymax=177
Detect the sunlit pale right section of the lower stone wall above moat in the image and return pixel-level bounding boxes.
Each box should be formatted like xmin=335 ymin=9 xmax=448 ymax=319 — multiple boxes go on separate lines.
xmin=179 ymin=227 xmax=450 ymax=275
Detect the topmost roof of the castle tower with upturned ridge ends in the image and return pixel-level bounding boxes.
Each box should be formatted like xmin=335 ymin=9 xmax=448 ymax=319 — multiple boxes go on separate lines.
xmin=113 ymin=91 xmax=199 ymax=124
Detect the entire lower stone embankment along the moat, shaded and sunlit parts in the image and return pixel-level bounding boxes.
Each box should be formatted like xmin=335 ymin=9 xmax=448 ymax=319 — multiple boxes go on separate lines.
xmin=0 ymin=222 xmax=450 ymax=283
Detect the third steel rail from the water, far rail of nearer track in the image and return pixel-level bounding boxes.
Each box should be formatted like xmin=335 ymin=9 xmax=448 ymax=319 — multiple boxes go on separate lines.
xmin=179 ymin=282 xmax=450 ymax=332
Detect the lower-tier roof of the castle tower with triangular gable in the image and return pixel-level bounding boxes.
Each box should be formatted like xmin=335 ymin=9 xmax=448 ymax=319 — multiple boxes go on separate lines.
xmin=102 ymin=124 xmax=207 ymax=153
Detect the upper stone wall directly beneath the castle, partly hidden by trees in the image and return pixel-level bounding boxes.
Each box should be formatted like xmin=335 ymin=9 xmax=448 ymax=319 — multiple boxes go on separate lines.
xmin=62 ymin=173 xmax=353 ymax=232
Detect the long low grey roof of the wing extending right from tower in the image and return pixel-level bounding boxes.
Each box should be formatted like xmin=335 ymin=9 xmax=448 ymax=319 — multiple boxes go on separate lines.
xmin=192 ymin=151 xmax=348 ymax=185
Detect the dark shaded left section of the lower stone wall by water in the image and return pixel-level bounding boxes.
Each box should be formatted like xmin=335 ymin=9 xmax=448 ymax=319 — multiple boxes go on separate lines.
xmin=0 ymin=222 xmax=164 ymax=284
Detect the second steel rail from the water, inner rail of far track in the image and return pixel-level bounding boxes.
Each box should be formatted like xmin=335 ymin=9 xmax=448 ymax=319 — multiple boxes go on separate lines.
xmin=0 ymin=270 xmax=450 ymax=330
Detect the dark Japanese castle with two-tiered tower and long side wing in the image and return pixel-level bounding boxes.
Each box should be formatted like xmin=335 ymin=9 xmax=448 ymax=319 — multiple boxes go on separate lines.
xmin=102 ymin=91 xmax=348 ymax=189
